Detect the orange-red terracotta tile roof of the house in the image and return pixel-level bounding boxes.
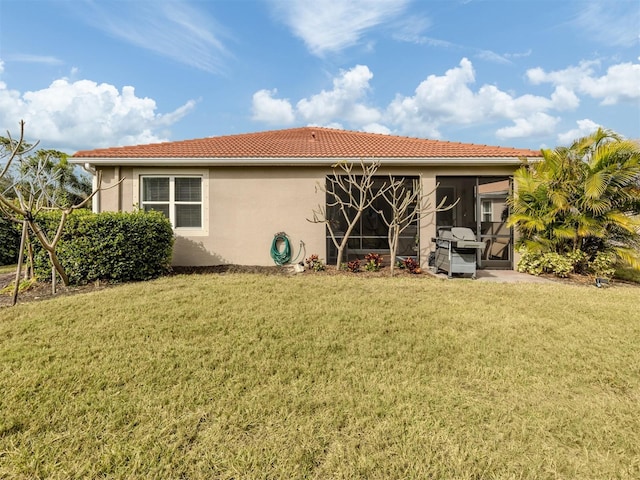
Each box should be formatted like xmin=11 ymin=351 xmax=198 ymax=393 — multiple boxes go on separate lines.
xmin=73 ymin=127 xmax=540 ymax=158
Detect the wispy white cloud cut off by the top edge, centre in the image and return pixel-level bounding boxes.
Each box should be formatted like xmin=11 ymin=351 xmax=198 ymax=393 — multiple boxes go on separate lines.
xmin=271 ymin=0 xmax=409 ymax=56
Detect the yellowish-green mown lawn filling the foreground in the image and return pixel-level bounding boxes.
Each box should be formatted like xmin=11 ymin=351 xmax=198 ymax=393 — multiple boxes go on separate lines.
xmin=0 ymin=274 xmax=640 ymax=479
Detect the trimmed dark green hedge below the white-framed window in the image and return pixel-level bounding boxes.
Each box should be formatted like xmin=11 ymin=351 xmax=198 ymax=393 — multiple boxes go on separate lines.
xmin=34 ymin=211 xmax=174 ymax=285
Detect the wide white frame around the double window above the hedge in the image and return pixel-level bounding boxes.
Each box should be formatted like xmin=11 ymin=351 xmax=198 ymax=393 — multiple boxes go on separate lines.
xmin=133 ymin=169 xmax=209 ymax=237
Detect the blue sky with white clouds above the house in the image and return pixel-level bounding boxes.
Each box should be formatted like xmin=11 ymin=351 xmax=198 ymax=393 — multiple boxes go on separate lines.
xmin=0 ymin=0 xmax=640 ymax=153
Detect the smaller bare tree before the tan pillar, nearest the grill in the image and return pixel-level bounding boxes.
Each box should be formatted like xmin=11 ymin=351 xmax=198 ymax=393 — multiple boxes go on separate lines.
xmin=378 ymin=175 xmax=458 ymax=276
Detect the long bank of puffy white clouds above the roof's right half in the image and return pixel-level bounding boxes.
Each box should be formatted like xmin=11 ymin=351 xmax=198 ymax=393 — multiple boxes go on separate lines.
xmin=253 ymin=58 xmax=592 ymax=138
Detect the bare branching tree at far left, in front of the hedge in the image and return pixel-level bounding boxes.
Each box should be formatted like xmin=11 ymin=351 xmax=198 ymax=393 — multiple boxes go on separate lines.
xmin=0 ymin=121 xmax=114 ymax=304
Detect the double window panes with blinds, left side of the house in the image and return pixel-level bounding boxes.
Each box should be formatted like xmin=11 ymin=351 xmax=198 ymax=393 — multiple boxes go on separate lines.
xmin=140 ymin=175 xmax=202 ymax=229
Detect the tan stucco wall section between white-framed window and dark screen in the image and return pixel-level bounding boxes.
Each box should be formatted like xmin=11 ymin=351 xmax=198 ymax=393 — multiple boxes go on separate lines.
xmin=196 ymin=167 xmax=326 ymax=265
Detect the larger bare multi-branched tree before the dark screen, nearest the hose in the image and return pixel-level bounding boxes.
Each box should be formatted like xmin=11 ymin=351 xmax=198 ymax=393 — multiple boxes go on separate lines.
xmin=307 ymin=159 xmax=389 ymax=269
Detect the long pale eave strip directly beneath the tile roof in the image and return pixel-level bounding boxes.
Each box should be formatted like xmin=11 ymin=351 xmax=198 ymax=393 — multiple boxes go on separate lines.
xmin=69 ymin=157 xmax=539 ymax=167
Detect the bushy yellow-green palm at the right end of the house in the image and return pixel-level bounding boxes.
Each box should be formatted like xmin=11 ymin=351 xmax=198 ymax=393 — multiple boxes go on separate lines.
xmin=509 ymin=129 xmax=640 ymax=276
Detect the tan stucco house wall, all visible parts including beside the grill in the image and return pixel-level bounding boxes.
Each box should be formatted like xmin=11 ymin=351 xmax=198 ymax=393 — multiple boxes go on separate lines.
xmin=99 ymin=166 xmax=515 ymax=267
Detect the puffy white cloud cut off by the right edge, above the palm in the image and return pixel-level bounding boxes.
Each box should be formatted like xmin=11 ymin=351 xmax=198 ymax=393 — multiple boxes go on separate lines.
xmin=527 ymin=61 xmax=640 ymax=105
